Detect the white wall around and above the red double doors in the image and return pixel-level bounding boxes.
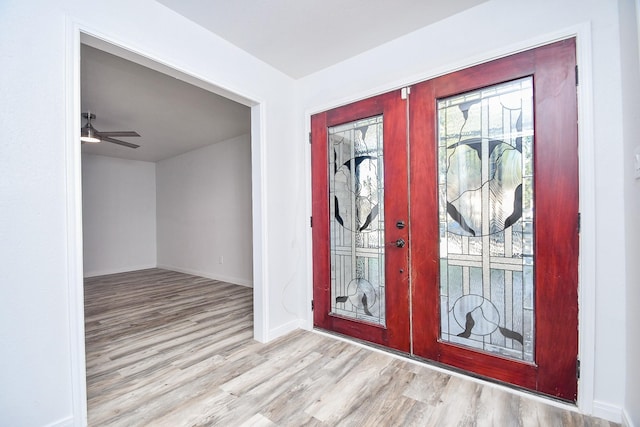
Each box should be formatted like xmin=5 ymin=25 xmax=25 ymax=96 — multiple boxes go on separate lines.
xmin=298 ymin=0 xmax=639 ymax=421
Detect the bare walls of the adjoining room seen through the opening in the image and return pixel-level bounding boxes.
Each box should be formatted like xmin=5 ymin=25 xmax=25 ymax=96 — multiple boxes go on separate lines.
xmin=82 ymin=135 xmax=253 ymax=286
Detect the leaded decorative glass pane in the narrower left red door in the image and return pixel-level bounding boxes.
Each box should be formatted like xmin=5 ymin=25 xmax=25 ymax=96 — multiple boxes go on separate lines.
xmin=328 ymin=116 xmax=385 ymax=326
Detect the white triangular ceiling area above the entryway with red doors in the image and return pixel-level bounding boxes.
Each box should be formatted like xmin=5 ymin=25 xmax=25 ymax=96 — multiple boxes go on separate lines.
xmin=157 ymin=0 xmax=487 ymax=79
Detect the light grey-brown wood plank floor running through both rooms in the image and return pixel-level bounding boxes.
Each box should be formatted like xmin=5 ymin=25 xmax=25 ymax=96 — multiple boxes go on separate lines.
xmin=85 ymin=269 xmax=616 ymax=427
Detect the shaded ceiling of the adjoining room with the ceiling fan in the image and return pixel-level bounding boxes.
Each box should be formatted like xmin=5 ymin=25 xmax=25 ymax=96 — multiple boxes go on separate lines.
xmin=81 ymin=44 xmax=251 ymax=162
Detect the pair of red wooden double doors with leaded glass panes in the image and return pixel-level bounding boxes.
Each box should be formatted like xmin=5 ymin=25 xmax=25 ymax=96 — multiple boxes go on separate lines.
xmin=312 ymin=39 xmax=578 ymax=401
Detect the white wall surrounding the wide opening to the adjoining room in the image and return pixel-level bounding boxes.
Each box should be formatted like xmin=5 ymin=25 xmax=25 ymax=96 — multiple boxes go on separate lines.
xmin=0 ymin=0 xmax=306 ymax=426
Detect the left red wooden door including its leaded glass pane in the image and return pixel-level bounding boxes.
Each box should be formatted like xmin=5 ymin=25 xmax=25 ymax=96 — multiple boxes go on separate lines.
xmin=311 ymin=91 xmax=410 ymax=352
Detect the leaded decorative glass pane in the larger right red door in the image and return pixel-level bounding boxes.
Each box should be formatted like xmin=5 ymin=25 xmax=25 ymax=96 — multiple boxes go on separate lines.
xmin=437 ymin=77 xmax=535 ymax=362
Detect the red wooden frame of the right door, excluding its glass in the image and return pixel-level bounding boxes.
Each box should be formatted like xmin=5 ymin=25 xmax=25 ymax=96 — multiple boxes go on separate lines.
xmin=409 ymin=39 xmax=578 ymax=401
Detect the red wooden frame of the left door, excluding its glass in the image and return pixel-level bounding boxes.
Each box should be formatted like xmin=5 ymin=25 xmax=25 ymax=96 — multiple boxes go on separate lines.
xmin=311 ymin=91 xmax=410 ymax=352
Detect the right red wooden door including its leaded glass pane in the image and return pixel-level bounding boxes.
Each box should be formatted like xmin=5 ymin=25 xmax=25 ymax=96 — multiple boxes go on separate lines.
xmin=409 ymin=39 xmax=579 ymax=401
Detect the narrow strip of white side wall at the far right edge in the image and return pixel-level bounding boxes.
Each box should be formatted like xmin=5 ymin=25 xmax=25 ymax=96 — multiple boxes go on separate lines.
xmin=619 ymin=0 xmax=640 ymax=426
